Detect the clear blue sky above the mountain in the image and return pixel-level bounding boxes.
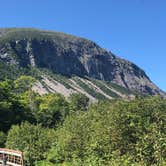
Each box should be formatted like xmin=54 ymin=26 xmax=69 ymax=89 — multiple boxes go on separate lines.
xmin=0 ymin=0 xmax=166 ymax=90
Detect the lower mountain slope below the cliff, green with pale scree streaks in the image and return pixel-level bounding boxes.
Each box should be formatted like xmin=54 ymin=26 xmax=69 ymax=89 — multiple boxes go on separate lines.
xmin=0 ymin=62 xmax=134 ymax=102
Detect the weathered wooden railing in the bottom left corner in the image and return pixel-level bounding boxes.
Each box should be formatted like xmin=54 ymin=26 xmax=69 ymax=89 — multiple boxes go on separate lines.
xmin=0 ymin=148 xmax=24 ymax=166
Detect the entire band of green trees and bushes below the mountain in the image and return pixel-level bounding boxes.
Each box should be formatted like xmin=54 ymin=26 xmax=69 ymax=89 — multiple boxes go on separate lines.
xmin=0 ymin=76 xmax=166 ymax=166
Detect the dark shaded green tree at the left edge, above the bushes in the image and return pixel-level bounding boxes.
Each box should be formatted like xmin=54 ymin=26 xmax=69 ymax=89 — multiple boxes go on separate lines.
xmin=0 ymin=80 xmax=28 ymax=132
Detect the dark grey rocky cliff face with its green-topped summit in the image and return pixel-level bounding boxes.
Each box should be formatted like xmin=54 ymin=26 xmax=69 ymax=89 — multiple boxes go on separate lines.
xmin=0 ymin=29 xmax=164 ymax=95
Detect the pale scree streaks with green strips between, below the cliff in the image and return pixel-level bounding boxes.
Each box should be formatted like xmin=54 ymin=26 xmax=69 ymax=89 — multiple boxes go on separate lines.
xmin=32 ymin=69 xmax=134 ymax=102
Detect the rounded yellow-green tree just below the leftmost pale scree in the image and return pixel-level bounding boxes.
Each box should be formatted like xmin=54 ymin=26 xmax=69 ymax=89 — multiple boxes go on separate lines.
xmin=34 ymin=94 xmax=69 ymax=127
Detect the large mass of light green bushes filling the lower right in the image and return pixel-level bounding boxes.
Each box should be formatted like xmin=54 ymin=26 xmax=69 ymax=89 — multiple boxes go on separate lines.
xmin=47 ymin=97 xmax=166 ymax=166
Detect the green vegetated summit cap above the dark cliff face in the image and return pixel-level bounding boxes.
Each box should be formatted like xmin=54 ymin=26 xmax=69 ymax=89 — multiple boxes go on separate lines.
xmin=0 ymin=28 xmax=91 ymax=48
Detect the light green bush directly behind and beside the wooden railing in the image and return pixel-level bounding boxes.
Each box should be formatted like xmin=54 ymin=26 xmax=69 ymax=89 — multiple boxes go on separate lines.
xmin=6 ymin=122 xmax=54 ymax=166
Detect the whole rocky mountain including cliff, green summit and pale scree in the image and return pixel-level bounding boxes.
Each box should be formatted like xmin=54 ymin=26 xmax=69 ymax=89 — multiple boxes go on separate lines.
xmin=0 ymin=28 xmax=165 ymax=99
